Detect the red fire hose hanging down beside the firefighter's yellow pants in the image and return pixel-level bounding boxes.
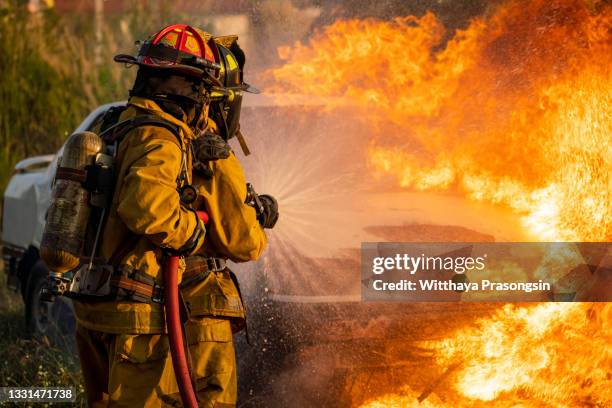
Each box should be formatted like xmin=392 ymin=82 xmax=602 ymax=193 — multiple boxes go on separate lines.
xmin=164 ymin=211 xmax=208 ymax=408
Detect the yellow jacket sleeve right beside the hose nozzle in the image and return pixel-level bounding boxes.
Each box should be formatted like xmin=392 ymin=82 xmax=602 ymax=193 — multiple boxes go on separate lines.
xmin=198 ymin=153 xmax=266 ymax=262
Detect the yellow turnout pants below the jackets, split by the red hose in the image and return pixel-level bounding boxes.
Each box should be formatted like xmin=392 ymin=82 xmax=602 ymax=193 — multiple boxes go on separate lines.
xmin=77 ymin=317 xmax=237 ymax=408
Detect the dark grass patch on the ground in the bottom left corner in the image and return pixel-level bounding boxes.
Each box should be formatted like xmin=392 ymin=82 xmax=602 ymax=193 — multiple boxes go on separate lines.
xmin=0 ymin=269 xmax=85 ymax=406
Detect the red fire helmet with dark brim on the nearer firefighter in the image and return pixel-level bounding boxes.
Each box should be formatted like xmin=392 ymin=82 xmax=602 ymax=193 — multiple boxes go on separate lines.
xmin=114 ymin=24 xmax=221 ymax=84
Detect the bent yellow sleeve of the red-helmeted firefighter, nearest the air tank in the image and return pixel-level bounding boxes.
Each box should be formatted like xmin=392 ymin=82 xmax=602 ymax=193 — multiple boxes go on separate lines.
xmin=117 ymin=128 xmax=204 ymax=252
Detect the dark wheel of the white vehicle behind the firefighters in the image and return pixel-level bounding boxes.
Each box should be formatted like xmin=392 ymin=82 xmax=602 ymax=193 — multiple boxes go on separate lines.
xmin=25 ymin=259 xmax=76 ymax=348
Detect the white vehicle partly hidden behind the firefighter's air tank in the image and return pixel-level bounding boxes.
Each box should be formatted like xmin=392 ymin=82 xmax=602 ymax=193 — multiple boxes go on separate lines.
xmin=2 ymin=102 xmax=120 ymax=343
